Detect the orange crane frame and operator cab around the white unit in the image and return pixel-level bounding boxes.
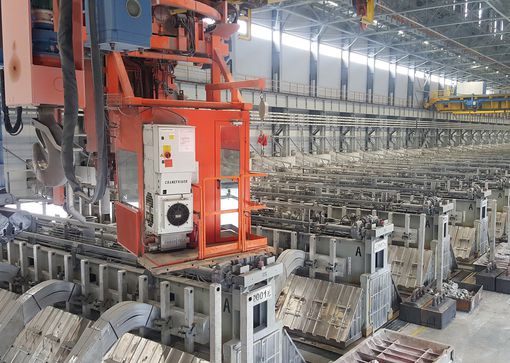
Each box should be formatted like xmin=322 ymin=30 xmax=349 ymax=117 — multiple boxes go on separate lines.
xmin=2 ymin=0 xmax=268 ymax=268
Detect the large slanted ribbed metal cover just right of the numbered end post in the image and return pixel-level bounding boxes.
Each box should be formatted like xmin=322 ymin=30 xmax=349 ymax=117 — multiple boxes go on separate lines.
xmin=278 ymin=275 xmax=362 ymax=343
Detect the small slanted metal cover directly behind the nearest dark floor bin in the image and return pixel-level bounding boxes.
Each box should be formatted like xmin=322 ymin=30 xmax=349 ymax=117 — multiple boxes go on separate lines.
xmin=388 ymin=245 xmax=433 ymax=290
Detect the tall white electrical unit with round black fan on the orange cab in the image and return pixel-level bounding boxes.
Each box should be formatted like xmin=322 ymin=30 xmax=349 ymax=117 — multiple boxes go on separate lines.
xmin=143 ymin=125 xmax=198 ymax=250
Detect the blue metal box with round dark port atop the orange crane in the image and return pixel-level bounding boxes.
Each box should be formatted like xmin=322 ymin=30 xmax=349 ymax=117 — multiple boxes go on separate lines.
xmin=85 ymin=0 xmax=152 ymax=51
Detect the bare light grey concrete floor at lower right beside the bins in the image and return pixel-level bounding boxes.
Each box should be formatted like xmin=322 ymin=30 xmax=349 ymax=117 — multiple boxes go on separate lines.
xmin=402 ymin=291 xmax=510 ymax=363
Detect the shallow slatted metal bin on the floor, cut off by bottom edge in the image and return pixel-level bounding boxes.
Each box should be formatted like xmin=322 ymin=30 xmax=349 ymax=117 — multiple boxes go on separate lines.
xmin=334 ymin=329 xmax=453 ymax=363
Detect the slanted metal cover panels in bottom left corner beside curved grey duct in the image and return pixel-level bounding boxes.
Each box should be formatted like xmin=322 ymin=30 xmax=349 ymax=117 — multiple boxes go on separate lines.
xmin=2 ymin=306 xmax=89 ymax=363
